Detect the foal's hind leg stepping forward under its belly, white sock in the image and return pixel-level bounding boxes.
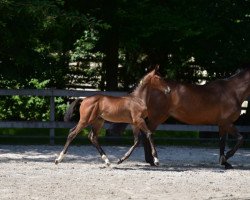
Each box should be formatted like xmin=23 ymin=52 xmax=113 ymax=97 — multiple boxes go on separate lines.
xmin=88 ymin=119 xmax=110 ymax=166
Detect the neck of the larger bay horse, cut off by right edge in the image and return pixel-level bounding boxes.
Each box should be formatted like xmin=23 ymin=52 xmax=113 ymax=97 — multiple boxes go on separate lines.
xmin=228 ymin=70 xmax=250 ymax=102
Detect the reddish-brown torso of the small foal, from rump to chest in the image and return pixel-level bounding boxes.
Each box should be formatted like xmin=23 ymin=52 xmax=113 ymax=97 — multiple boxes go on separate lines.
xmin=80 ymin=95 xmax=147 ymax=124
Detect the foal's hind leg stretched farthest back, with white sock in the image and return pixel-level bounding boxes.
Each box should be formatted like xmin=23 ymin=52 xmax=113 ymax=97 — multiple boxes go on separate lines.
xmin=55 ymin=121 xmax=86 ymax=164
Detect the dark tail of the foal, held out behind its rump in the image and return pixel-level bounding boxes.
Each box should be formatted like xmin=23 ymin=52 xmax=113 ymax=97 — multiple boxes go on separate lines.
xmin=63 ymin=98 xmax=83 ymax=122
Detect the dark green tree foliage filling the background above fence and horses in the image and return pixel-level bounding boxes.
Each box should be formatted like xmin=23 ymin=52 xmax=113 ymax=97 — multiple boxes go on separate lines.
xmin=0 ymin=0 xmax=250 ymax=120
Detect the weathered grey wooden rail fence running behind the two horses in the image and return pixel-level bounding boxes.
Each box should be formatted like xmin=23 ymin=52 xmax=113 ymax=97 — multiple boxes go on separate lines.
xmin=0 ymin=89 xmax=250 ymax=144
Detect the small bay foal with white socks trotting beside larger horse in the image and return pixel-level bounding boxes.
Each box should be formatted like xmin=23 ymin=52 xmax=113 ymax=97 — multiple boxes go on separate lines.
xmin=55 ymin=72 xmax=170 ymax=166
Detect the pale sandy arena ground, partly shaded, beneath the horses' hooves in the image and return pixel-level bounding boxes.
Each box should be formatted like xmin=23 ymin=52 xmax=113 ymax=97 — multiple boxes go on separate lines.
xmin=0 ymin=145 xmax=250 ymax=200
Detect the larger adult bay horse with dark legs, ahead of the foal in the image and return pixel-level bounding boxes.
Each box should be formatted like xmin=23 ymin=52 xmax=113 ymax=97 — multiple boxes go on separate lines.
xmin=137 ymin=68 xmax=250 ymax=169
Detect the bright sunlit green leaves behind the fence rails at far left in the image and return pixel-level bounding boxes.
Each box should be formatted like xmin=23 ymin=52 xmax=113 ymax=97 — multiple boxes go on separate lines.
xmin=0 ymin=79 xmax=67 ymax=121
